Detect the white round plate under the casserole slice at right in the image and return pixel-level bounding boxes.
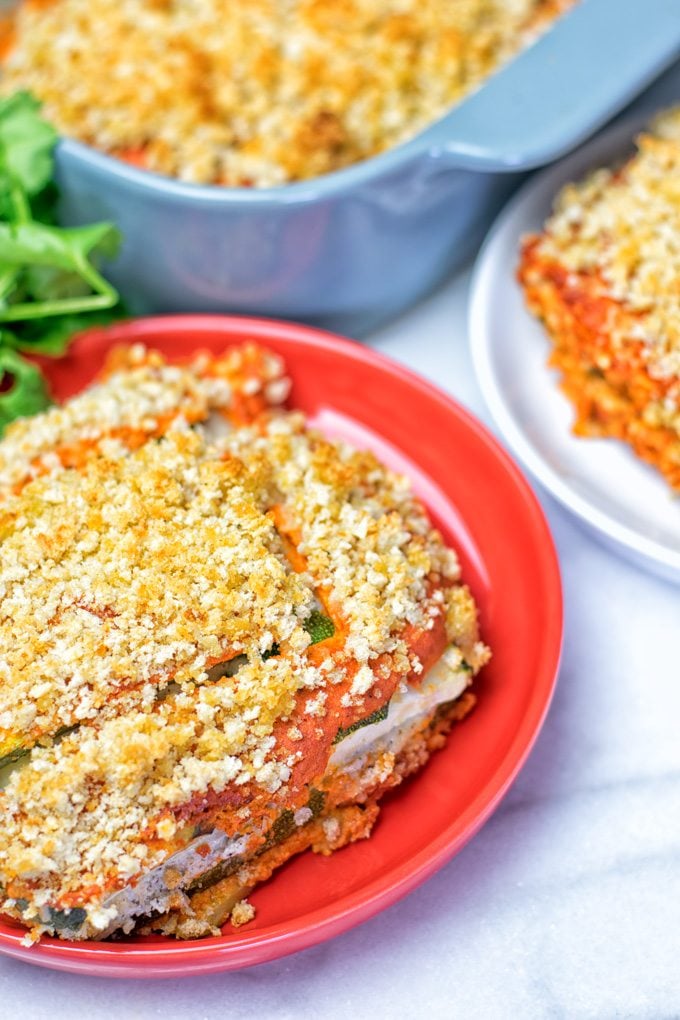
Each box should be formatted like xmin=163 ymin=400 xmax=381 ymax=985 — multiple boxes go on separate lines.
xmin=470 ymin=115 xmax=680 ymax=582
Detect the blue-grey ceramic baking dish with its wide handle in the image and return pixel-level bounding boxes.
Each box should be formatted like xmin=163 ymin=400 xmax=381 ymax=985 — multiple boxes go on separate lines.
xmin=50 ymin=0 xmax=680 ymax=337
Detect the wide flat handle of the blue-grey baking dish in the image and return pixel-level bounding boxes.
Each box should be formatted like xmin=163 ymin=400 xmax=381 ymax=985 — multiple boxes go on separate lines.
xmin=412 ymin=0 xmax=680 ymax=171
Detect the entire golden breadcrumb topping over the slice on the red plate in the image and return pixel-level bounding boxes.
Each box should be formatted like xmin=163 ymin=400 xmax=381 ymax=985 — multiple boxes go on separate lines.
xmin=0 ymin=342 xmax=487 ymax=931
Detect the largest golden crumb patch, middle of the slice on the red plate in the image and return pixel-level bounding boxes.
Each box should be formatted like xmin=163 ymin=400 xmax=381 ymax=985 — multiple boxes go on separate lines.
xmin=0 ymin=432 xmax=313 ymax=755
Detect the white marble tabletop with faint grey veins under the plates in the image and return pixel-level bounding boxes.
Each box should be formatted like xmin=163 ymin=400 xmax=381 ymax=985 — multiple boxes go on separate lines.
xmin=0 ymin=265 xmax=680 ymax=1020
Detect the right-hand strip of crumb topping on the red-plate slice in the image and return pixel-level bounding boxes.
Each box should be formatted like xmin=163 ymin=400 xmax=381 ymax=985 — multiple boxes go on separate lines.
xmin=223 ymin=415 xmax=460 ymax=669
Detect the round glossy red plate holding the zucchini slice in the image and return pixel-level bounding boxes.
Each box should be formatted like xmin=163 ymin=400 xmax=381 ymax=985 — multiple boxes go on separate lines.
xmin=0 ymin=315 xmax=562 ymax=977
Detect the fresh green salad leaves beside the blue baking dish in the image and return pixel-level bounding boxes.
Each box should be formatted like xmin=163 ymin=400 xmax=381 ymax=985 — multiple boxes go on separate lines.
xmin=0 ymin=92 xmax=122 ymax=434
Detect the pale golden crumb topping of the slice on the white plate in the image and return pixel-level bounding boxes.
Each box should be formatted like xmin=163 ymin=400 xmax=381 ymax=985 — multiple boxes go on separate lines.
xmin=536 ymin=107 xmax=680 ymax=378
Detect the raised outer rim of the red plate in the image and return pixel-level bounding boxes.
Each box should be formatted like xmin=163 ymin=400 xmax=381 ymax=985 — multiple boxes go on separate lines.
xmin=0 ymin=314 xmax=563 ymax=977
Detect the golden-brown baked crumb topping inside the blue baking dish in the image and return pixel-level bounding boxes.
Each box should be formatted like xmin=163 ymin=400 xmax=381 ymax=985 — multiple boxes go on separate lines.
xmin=0 ymin=0 xmax=574 ymax=186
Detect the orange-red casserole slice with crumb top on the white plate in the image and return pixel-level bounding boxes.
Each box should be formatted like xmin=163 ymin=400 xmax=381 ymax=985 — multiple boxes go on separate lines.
xmin=519 ymin=107 xmax=680 ymax=490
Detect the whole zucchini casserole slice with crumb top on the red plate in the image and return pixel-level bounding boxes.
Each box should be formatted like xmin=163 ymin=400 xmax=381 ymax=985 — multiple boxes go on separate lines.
xmin=0 ymin=345 xmax=488 ymax=940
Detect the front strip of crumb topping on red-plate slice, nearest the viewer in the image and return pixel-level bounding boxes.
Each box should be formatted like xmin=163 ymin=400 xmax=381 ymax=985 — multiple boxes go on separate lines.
xmin=0 ymin=657 xmax=300 ymax=902
